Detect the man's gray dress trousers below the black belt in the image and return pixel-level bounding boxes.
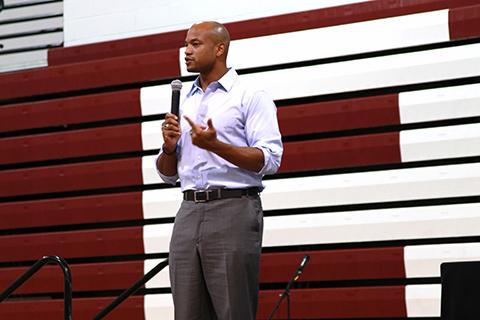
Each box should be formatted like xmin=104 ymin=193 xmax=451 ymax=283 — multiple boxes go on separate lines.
xmin=169 ymin=196 xmax=263 ymax=320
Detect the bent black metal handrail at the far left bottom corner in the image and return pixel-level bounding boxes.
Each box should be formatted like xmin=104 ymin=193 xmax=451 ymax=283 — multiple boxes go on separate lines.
xmin=0 ymin=256 xmax=72 ymax=320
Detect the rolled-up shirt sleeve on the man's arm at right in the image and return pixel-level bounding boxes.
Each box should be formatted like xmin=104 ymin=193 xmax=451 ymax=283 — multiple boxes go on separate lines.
xmin=245 ymin=91 xmax=283 ymax=175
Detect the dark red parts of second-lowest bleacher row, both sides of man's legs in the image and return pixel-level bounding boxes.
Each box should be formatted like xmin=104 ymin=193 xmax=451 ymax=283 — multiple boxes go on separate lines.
xmin=0 ymin=247 xmax=405 ymax=293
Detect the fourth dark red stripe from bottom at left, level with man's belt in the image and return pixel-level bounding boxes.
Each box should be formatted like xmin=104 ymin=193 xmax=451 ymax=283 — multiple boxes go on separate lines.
xmin=0 ymin=192 xmax=143 ymax=230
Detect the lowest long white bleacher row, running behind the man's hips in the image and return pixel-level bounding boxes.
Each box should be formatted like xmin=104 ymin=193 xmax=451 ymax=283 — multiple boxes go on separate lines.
xmin=143 ymin=204 xmax=480 ymax=253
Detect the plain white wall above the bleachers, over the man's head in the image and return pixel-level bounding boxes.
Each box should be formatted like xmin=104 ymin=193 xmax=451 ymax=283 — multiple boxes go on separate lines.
xmin=64 ymin=0 xmax=370 ymax=46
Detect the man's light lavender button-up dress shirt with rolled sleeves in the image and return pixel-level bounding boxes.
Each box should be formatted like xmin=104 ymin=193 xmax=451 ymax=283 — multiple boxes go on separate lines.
xmin=159 ymin=68 xmax=283 ymax=191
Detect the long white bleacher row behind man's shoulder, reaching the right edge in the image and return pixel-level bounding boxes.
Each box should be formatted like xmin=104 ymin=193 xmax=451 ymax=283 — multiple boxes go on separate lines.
xmin=141 ymin=44 xmax=480 ymax=115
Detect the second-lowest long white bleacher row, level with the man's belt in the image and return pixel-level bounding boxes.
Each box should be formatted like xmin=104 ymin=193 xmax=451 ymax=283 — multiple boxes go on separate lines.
xmin=144 ymin=162 xmax=480 ymax=218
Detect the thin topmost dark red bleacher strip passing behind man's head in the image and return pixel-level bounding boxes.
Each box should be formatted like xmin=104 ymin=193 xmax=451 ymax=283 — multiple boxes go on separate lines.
xmin=48 ymin=0 xmax=479 ymax=66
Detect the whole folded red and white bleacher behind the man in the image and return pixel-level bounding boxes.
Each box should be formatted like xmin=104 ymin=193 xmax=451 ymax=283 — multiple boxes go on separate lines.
xmin=0 ymin=0 xmax=480 ymax=320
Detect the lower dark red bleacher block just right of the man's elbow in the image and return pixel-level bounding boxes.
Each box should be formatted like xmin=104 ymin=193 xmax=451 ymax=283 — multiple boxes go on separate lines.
xmin=279 ymin=132 xmax=402 ymax=172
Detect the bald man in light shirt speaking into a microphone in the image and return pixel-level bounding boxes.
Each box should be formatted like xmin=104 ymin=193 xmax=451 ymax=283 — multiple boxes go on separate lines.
xmin=156 ymin=22 xmax=283 ymax=320
